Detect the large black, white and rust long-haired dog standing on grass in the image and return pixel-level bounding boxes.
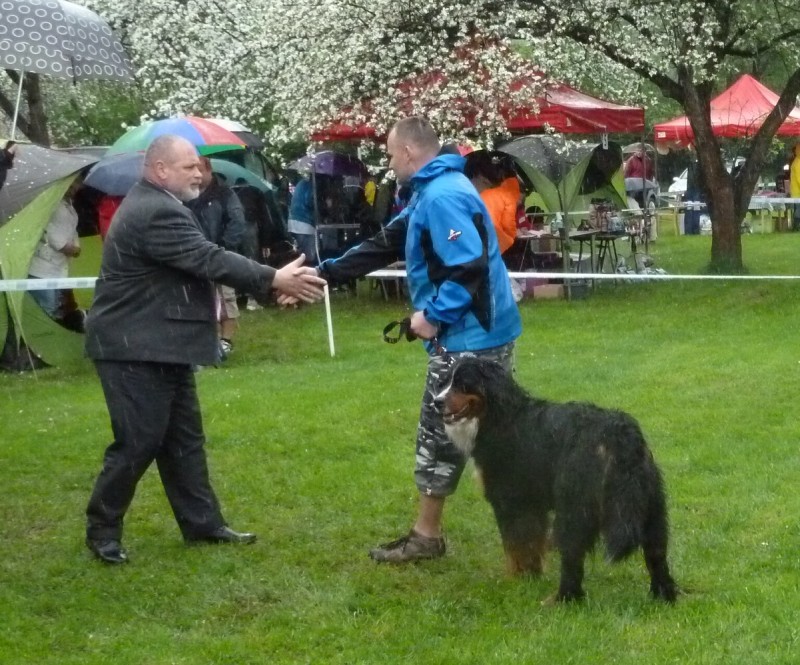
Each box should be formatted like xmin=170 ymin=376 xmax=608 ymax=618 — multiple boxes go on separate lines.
xmin=436 ymin=357 xmax=678 ymax=602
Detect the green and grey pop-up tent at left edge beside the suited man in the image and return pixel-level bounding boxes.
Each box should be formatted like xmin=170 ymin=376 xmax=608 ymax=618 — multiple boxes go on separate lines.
xmin=0 ymin=144 xmax=97 ymax=369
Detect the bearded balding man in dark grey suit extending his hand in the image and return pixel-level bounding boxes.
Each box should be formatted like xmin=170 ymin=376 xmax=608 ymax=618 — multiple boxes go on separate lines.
xmin=86 ymin=136 xmax=325 ymax=564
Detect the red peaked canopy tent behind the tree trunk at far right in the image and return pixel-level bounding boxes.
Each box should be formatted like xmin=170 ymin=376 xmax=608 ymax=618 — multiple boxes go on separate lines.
xmin=653 ymin=74 xmax=800 ymax=146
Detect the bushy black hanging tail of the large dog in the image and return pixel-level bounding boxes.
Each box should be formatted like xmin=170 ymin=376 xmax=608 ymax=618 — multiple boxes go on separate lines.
xmin=602 ymin=422 xmax=666 ymax=561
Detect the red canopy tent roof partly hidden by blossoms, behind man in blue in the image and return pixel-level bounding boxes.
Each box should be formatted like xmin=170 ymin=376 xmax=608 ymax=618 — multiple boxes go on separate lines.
xmin=311 ymin=82 xmax=644 ymax=141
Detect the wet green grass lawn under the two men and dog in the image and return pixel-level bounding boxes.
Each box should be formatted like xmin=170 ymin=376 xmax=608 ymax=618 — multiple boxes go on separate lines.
xmin=0 ymin=234 xmax=800 ymax=665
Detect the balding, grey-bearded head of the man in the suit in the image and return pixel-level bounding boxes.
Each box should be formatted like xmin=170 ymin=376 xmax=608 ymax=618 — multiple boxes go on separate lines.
xmin=143 ymin=134 xmax=202 ymax=201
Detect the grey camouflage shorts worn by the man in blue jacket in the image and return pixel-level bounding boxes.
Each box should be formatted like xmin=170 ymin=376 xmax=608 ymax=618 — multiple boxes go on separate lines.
xmin=414 ymin=342 xmax=514 ymax=496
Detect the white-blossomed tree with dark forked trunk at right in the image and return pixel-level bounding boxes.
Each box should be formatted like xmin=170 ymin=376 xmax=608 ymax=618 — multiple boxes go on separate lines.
xmin=86 ymin=0 xmax=800 ymax=271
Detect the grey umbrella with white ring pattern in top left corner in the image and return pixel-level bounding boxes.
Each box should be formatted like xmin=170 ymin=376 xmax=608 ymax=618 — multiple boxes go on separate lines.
xmin=0 ymin=0 xmax=133 ymax=139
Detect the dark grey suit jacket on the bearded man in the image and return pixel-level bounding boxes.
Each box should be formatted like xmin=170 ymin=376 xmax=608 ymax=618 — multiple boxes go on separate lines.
xmin=86 ymin=180 xmax=275 ymax=365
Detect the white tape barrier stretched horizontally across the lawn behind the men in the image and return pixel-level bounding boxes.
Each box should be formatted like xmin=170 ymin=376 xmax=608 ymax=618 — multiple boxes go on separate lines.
xmin=0 ymin=269 xmax=800 ymax=293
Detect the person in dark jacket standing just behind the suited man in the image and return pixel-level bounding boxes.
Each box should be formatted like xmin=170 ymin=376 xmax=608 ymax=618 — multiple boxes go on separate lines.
xmin=186 ymin=157 xmax=247 ymax=360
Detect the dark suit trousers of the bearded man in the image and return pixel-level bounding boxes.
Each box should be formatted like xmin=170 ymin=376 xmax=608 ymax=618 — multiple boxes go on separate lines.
xmin=86 ymin=360 xmax=225 ymax=540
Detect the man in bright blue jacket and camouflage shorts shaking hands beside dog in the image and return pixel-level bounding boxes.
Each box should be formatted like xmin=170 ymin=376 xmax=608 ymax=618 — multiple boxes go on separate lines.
xmin=319 ymin=117 xmax=522 ymax=563
